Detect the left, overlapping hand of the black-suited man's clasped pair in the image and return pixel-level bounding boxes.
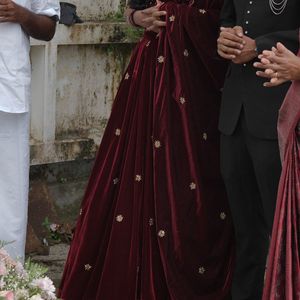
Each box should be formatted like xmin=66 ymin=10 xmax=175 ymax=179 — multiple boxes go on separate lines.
xmin=217 ymin=26 xmax=245 ymax=60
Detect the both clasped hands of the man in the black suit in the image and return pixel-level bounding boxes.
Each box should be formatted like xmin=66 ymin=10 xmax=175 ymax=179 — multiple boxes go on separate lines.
xmin=218 ymin=26 xmax=257 ymax=64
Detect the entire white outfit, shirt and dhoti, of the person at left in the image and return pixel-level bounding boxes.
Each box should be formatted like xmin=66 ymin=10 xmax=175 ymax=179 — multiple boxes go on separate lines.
xmin=0 ymin=0 xmax=60 ymax=259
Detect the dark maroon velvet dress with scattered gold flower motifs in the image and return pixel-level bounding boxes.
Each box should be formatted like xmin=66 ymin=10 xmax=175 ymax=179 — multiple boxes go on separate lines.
xmin=60 ymin=0 xmax=234 ymax=300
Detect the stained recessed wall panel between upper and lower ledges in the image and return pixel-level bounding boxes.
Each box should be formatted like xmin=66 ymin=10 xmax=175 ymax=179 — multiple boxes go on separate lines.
xmin=56 ymin=45 xmax=131 ymax=145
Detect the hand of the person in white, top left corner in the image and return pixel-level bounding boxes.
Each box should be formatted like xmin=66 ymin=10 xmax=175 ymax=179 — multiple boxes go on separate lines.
xmin=0 ymin=0 xmax=28 ymax=24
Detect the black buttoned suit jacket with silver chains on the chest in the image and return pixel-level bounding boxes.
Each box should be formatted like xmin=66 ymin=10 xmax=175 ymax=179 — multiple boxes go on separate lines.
xmin=219 ymin=0 xmax=300 ymax=139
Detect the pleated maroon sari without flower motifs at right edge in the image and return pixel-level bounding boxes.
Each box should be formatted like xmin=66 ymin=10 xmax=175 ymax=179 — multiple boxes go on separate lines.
xmin=263 ymin=53 xmax=300 ymax=300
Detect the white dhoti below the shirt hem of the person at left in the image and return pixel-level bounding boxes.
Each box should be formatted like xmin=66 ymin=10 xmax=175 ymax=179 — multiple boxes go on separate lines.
xmin=0 ymin=112 xmax=29 ymax=259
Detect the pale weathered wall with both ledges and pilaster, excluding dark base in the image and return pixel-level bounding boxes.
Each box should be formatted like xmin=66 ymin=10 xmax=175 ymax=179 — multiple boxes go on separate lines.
xmin=31 ymin=21 xmax=137 ymax=165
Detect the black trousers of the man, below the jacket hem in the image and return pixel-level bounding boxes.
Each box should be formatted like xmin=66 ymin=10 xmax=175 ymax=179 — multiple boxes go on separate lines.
xmin=221 ymin=114 xmax=281 ymax=300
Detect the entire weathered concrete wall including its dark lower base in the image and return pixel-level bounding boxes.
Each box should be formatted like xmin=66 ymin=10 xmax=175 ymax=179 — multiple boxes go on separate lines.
xmin=27 ymin=0 xmax=142 ymax=252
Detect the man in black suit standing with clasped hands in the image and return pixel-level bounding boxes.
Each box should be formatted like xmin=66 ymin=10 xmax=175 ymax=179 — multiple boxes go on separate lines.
xmin=218 ymin=0 xmax=300 ymax=300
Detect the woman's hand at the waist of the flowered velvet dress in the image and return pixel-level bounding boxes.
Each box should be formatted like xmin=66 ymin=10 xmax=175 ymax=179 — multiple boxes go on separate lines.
xmin=141 ymin=3 xmax=167 ymax=33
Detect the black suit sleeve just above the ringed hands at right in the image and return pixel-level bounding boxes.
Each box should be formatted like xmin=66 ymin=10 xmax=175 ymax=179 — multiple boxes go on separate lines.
xmin=255 ymin=29 xmax=299 ymax=54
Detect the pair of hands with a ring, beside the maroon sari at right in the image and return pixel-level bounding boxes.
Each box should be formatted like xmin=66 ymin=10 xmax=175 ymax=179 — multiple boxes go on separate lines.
xmin=254 ymin=43 xmax=300 ymax=87
